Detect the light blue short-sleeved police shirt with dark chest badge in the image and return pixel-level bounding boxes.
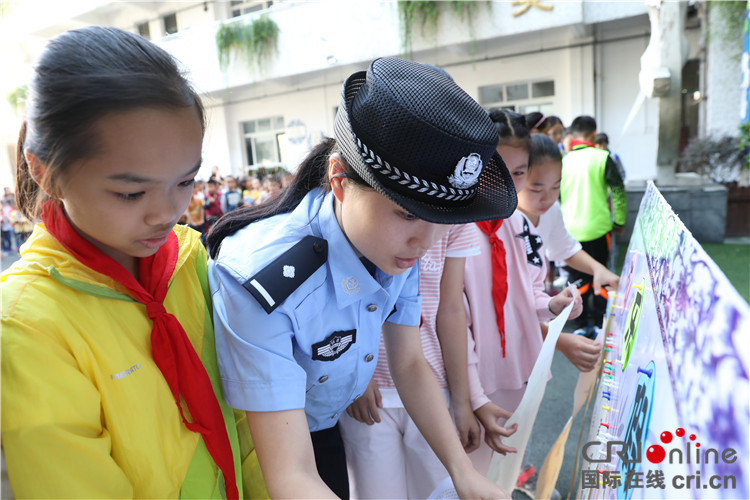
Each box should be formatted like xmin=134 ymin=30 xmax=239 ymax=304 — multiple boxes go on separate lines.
xmin=209 ymin=189 xmax=421 ymax=431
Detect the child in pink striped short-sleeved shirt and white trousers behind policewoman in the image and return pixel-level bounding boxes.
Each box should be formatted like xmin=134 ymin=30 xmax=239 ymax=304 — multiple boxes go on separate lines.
xmin=340 ymin=224 xmax=516 ymax=498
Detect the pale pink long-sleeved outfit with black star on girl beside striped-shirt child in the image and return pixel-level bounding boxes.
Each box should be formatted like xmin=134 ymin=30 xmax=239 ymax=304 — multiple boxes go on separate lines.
xmin=464 ymin=210 xmax=555 ymax=474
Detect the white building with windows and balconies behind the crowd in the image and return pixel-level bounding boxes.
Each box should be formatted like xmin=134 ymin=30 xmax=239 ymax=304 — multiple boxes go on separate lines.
xmin=0 ymin=0 xmax=741 ymax=188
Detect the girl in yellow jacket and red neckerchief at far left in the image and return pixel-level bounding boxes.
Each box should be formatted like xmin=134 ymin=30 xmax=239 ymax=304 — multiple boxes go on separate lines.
xmin=1 ymin=27 xmax=265 ymax=498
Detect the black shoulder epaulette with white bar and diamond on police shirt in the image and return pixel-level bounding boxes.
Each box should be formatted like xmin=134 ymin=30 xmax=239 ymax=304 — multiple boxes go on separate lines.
xmin=242 ymin=236 xmax=328 ymax=314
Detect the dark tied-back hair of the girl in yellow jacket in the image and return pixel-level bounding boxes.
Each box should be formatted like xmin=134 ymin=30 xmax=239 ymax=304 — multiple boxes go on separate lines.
xmin=16 ymin=26 xmax=205 ymax=220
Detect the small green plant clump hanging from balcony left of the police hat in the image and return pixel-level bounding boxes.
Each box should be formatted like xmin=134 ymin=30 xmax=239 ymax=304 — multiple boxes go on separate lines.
xmin=216 ymin=14 xmax=279 ymax=70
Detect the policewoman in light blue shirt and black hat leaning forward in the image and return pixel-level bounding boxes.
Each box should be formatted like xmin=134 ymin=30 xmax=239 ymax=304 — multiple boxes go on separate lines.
xmin=208 ymin=58 xmax=516 ymax=498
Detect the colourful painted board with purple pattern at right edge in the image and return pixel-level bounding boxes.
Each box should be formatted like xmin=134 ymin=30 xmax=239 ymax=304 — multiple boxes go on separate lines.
xmin=578 ymin=183 xmax=750 ymax=499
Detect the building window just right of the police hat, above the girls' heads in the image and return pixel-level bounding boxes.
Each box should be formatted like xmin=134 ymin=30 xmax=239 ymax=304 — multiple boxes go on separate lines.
xmin=479 ymin=80 xmax=555 ymax=115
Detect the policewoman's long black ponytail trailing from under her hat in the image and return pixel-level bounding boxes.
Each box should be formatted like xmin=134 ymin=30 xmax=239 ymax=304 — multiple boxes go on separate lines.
xmin=207 ymin=138 xmax=369 ymax=259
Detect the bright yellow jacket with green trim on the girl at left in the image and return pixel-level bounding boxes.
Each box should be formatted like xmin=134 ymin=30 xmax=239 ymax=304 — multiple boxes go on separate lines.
xmin=0 ymin=224 xmax=267 ymax=499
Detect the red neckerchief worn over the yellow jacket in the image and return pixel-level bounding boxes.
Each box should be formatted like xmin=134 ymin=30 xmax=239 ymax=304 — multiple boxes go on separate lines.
xmin=42 ymin=201 xmax=239 ymax=499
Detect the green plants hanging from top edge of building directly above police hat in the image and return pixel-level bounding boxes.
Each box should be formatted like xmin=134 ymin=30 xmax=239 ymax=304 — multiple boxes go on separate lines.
xmin=398 ymin=0 xmax=491 ymax=57
